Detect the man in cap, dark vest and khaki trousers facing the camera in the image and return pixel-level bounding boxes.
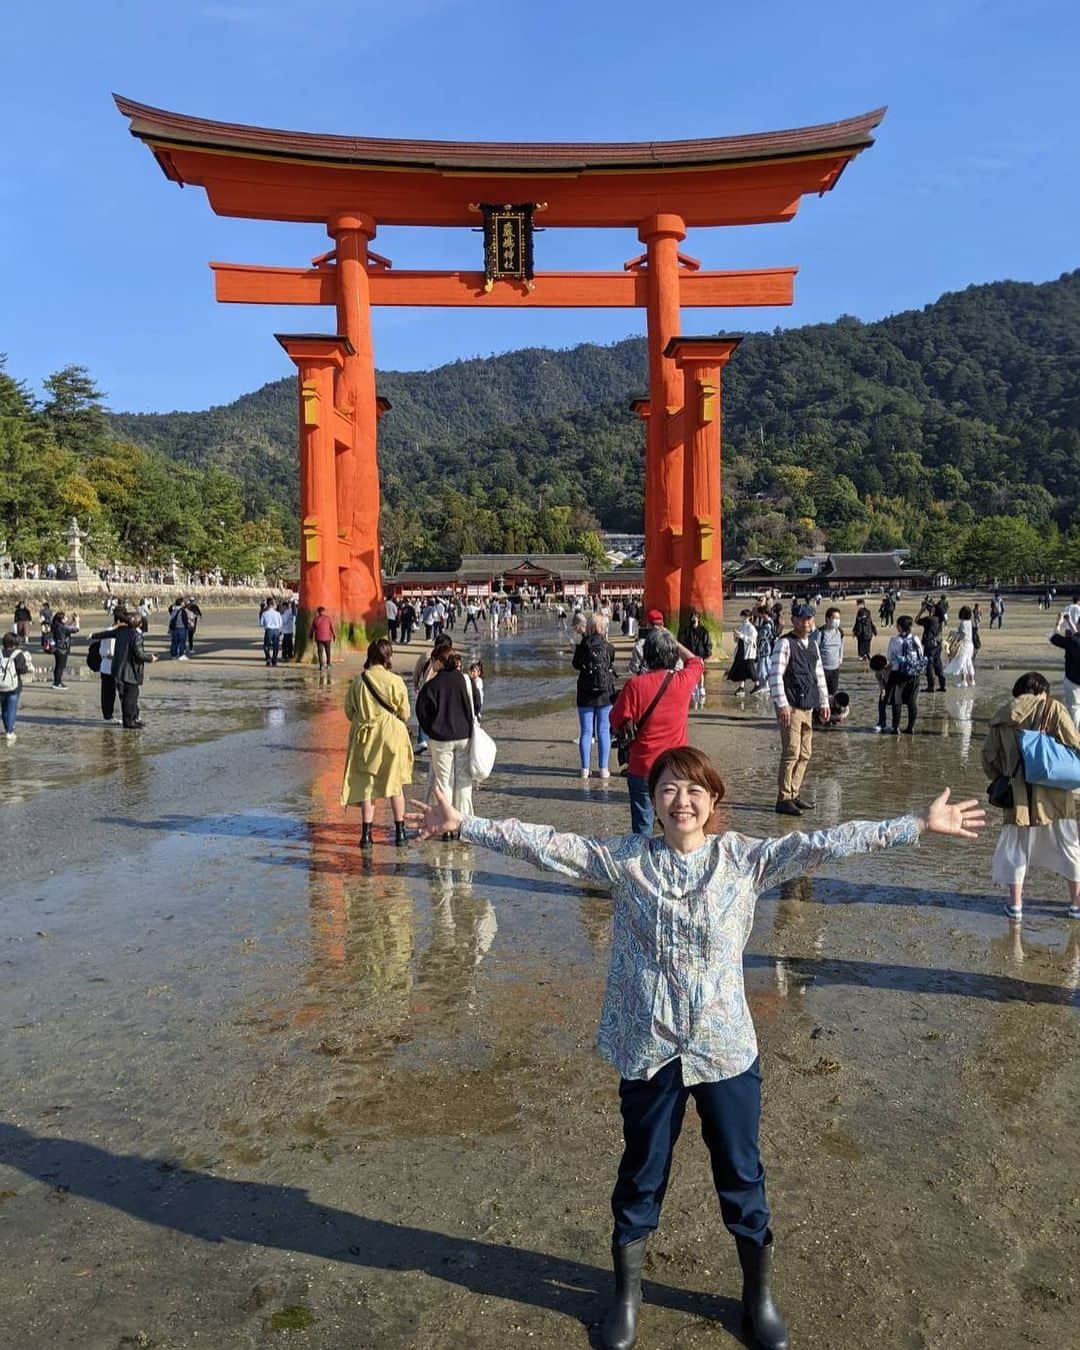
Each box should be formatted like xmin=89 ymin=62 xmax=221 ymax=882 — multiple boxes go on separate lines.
xmin=768 ymin=601 xmax=830 ymax=815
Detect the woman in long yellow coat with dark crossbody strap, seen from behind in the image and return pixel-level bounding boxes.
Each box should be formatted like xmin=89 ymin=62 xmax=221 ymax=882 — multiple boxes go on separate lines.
xmin=342 ymin=637 xmax=413 ymax=849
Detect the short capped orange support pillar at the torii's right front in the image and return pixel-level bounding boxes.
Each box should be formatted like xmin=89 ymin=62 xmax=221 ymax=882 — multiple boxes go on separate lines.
xmin=664 ymin=338 xmax=741 ymax=637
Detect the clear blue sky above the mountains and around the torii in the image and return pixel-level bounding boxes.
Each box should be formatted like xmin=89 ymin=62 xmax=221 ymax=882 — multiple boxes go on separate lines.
xmin=0 ymin=0 xmax=1080 ymax=410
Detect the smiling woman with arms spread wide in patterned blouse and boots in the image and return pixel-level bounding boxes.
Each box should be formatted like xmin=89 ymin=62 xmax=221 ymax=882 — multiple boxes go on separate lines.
xmin=412 ymin=745 xmax=984 ymax=1350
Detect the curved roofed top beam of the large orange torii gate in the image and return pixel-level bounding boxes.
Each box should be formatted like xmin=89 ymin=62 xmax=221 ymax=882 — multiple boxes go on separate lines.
xmin=115 ymin=96 xmax=886 ymax=227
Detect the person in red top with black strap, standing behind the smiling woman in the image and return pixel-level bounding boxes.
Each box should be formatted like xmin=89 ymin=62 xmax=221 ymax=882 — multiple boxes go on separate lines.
xmin=612 ymin=628 xmax=705 ymax=834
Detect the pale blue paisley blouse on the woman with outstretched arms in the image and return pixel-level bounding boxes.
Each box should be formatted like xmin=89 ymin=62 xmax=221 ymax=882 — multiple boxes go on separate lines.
xmin=462 ymin=815 xmax=921 ymax=1084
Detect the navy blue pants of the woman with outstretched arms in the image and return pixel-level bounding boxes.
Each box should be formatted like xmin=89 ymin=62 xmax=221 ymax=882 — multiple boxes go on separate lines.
xmin=612 ymin=1060 xmax=770 ymax=1246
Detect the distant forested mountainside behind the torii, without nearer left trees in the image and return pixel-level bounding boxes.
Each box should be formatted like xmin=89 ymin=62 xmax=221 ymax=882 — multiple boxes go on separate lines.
xmin=112 ymin=271 xmax=1080 ymax=564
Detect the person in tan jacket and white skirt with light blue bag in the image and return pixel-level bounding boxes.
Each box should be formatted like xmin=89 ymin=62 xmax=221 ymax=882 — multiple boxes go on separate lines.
xmin=983 ymin=671 xmax=1080 ymax=921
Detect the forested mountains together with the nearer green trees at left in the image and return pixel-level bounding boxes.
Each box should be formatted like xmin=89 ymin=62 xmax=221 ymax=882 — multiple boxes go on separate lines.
xmin=0 ymin=271 xmax=1080 ymax=575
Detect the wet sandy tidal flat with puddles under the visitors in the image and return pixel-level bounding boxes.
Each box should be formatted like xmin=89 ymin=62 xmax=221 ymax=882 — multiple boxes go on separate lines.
xmin=0 ymin=598 xmax=1080 ymax=1350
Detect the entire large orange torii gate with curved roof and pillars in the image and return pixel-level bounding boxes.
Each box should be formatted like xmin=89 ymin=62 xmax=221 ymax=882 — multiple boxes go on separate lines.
xmin=116 ymin=97 xmax=884 ymax=641
